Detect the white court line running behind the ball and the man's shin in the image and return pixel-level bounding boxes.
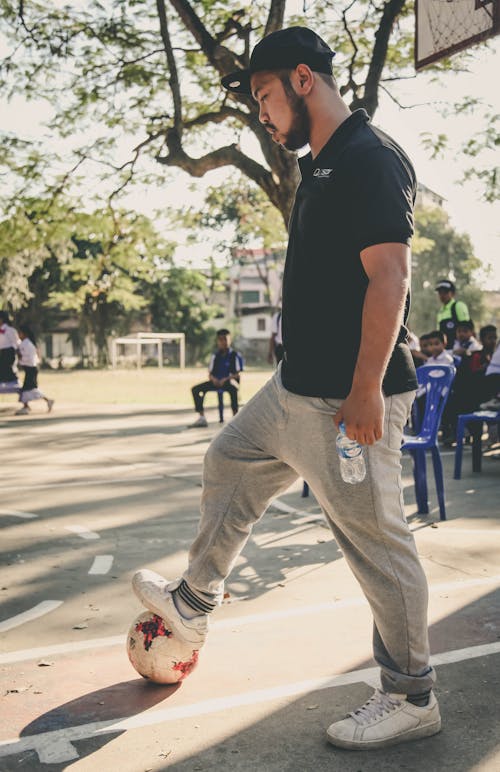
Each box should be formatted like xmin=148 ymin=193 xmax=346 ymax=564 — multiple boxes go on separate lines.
xmin=0 ymin=574 xmax=500 ymax=665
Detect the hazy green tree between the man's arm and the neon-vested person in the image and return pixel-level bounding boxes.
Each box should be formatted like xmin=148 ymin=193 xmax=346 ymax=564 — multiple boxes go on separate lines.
xmin=409 ymin=208 xmax=483 ymax=335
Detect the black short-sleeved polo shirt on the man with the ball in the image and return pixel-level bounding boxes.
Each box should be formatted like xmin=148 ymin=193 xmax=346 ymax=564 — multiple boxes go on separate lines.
xmin=281 ymin=110 xmax=416 ymax=399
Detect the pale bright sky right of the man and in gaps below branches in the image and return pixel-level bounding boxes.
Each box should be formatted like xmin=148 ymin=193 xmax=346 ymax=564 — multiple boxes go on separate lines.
xmin=0 ymin=17 xmax=500 ymax=290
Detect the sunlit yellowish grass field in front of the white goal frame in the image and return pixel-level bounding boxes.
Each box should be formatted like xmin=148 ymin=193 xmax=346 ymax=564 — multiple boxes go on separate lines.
xmin=0 ymin=367 xmax=272 ymax=407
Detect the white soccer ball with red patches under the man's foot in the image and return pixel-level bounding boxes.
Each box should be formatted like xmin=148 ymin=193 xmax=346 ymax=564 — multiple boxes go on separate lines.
xmin=127 ymin=611 xmax=198 ymax=684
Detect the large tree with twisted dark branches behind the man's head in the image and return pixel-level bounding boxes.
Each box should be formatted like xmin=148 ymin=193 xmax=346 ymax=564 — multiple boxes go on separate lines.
xmin=0 ymin=0 xmax=476 ymax=229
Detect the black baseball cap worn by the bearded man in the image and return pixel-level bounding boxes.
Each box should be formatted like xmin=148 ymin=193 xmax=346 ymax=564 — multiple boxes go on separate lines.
xmin=221 ymin=27 xmax=335 ymax=94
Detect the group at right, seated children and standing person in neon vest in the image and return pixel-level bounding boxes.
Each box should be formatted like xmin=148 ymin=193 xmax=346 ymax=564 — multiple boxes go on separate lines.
xmin=410 ymin=279 xmax=500 ymax=445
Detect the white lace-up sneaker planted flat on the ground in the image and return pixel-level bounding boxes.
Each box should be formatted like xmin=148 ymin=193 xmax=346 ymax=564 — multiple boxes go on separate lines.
xmin=326 ymin=689 xmax=441 ymax=750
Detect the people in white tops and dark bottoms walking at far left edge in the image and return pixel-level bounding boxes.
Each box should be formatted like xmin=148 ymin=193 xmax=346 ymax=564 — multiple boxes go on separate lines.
xmin=0 ymin=311 xmax=54 ymax=415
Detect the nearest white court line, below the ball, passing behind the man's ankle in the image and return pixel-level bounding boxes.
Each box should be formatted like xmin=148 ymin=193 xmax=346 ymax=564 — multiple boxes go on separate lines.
xmin=0 ymin=642 xmax=500 ymax=763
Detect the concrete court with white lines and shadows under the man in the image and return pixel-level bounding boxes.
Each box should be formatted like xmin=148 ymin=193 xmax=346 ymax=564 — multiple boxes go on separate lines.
xmin=0 ymin=402 xmax=500 ymax=772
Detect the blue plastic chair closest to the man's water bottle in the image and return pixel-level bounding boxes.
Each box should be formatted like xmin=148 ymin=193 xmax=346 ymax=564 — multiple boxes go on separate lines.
xmin=402 ymin=365 xmax=456 ymax=520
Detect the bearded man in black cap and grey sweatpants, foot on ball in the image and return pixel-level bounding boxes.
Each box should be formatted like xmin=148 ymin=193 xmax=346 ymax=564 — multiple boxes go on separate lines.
xmin=133 ymin=27 xmax=441 ymax=749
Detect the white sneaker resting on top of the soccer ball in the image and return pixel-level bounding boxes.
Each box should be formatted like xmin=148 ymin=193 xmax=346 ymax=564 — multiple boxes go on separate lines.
xmin=132 ymin=568 xmax=208 ymax=648
